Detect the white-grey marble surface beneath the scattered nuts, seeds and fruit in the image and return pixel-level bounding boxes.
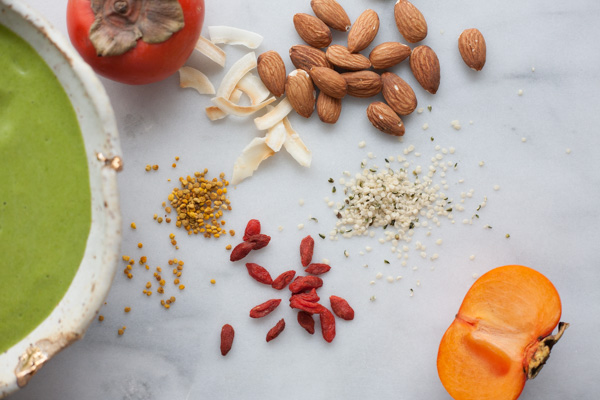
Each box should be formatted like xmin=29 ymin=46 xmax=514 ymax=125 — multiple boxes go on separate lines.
xmin=9 ymin=0 xmax=600 ymax=400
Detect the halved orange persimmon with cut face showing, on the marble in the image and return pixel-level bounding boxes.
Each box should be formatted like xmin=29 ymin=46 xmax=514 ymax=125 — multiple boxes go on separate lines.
xmin=437 ymin=265 xmax=568 ymax=400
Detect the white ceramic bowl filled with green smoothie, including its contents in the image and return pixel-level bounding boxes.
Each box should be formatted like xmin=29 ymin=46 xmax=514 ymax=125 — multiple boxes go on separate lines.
xmin=0 ymin=0 xmax=122 ymax=398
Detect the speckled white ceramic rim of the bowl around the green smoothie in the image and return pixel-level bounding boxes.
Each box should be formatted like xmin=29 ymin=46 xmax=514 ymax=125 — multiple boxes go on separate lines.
xmin=0 ymin=0 xmax=122 ymax=398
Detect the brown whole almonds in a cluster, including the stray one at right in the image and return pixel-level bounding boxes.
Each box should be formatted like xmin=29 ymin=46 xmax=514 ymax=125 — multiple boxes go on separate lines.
xmin=257 ymin=0 xmax=485 ymax=136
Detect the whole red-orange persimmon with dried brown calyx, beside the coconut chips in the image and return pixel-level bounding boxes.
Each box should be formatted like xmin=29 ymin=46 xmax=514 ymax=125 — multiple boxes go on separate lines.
xmin=67 ymin=0 xmax=204 ymax=85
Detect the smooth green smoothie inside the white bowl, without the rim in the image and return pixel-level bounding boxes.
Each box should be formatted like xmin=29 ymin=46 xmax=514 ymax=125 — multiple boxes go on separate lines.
xmin=0 ymin=25 xmax=92 ymax=352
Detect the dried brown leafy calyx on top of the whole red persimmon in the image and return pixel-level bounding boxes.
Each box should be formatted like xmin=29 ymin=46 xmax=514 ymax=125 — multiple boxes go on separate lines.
xmin=89 ymin=0 xmax=184 ymax=57
